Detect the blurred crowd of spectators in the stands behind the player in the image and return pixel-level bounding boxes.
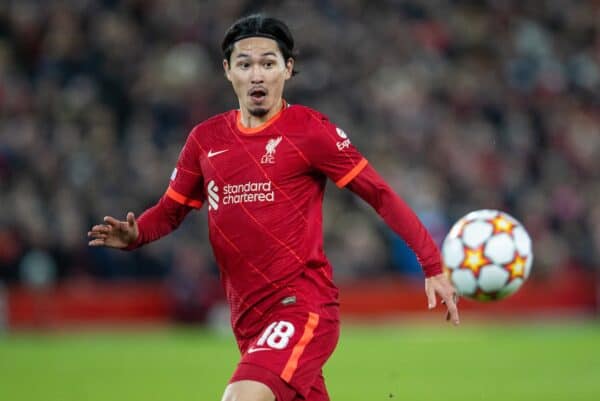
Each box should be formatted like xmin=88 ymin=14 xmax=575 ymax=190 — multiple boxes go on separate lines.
xmin=0 ymin=0 xmax=600 ymax=288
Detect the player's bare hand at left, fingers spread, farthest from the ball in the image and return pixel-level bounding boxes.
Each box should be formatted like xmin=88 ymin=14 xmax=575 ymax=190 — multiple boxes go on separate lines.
xmin=88 ymin=212 xmax=139 ymax=248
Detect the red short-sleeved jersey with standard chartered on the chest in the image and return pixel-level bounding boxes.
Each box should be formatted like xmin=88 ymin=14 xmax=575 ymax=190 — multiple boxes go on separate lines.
xmin=167 ymin=104 xmax=367 ymax=337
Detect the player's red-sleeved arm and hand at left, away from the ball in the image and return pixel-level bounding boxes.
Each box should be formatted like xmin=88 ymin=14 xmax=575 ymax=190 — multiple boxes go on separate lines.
xmin=88 ymin=127 xmax=204 ymax=250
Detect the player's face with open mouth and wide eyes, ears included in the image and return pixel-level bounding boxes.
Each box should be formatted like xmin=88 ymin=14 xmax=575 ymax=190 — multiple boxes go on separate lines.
xmin=223 ymin=37 xmax=294 ymax=121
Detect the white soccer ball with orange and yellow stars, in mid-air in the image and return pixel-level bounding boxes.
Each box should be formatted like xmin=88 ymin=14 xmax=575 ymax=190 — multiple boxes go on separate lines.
xmin=442 ymin=210 xmax=533 ymax=301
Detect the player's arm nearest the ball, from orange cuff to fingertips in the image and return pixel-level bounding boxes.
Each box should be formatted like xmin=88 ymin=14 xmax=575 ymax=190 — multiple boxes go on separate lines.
xmin=346 ymin=165 xmax=459 ymax=324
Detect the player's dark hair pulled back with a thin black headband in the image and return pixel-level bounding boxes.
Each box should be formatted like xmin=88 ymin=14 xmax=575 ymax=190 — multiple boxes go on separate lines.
xmin=221 ymin=14 xmax=297 ymax=75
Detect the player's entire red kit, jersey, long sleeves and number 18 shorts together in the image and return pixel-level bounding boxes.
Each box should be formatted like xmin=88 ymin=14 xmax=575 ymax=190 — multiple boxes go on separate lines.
xmin=128 ymin=104 xmax=442 ymax=401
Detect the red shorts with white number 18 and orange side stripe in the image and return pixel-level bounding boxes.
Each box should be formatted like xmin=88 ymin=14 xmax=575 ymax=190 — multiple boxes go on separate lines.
xmin=230 ymin=307 xmax=339 ymax=401
